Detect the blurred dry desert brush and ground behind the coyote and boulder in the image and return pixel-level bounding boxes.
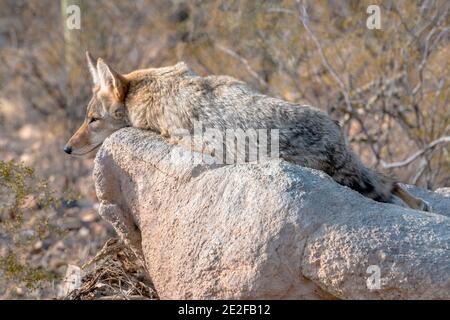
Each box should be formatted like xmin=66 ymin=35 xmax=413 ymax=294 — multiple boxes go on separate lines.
xmin=0 ymin=0 xmax=450 ymax=298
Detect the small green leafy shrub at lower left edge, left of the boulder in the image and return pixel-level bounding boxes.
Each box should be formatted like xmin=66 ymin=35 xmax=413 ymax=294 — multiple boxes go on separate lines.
xmin=0 ymin=160 xmax=64 ymax=290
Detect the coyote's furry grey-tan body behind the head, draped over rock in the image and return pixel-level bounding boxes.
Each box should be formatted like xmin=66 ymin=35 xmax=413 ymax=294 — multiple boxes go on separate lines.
xmin=125 ymin=63 xmax=393 ymax=202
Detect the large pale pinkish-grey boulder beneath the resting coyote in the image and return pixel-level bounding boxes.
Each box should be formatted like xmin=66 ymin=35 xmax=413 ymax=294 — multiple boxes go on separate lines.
xmin=94 ymin=128 xmax=450 ymax=299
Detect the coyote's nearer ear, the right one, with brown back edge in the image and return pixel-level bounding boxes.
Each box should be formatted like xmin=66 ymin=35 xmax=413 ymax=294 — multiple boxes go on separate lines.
xmin=97 ymin=58 xmax=128 ymax=101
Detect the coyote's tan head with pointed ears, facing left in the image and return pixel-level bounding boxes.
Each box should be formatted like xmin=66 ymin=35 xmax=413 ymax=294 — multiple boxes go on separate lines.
xmin=64 ymin=52 xmax=129 ymax=155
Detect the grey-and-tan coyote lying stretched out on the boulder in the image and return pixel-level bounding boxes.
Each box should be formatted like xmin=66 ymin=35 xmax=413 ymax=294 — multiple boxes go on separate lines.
xmin=64 ymin=52 xmax=430 ymax=211
